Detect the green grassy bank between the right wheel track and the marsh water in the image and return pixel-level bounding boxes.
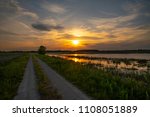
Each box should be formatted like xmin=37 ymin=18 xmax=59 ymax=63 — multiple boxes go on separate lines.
xmin=38 ymin=55 xmax=150 ymax=99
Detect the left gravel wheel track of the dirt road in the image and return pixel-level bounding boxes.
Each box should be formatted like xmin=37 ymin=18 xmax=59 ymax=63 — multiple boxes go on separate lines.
xmin=14 ymin=57 xmax=40 ymax=100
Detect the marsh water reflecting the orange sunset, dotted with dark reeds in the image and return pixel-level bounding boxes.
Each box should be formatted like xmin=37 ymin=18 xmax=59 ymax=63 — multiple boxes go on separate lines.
xmin=48 ymin=54 xmax=150 ymax=73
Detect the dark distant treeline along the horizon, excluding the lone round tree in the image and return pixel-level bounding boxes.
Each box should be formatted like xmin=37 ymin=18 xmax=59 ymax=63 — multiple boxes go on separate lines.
xmin=0 ymin=49 xmax=150 ymax=54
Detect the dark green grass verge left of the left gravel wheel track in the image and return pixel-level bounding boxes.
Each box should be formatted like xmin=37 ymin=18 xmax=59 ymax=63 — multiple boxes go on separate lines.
xmin=0 ymin=55 xmax=29 ymax=100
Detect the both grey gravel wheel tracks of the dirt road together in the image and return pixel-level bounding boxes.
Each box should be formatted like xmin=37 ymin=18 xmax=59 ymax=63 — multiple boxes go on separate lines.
xmin=14 ymin=57 xmax=90 ymax=100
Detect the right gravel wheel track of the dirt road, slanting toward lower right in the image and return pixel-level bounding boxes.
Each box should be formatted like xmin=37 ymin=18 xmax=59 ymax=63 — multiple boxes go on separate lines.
xmin=37 ymin=58 xmax=89 ymax=100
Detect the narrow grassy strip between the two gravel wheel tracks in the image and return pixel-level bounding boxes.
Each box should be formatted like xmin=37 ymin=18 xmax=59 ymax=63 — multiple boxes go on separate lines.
xmin=33 ymin=57 xmax=62 ymax=100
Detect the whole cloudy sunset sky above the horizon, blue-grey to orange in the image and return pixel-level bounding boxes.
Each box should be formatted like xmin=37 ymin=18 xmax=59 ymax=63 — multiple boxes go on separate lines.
xmin=0 ymin=0 xmax=150 ymax=50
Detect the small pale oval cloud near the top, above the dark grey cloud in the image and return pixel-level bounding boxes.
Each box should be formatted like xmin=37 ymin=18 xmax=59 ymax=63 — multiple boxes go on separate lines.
xmin=43 ymin=3 xmax=66 ymax=14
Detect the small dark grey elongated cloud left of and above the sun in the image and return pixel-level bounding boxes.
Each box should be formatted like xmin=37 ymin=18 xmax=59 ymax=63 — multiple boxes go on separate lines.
xmin=32 ymin=23 xmax=64 ymax=31
